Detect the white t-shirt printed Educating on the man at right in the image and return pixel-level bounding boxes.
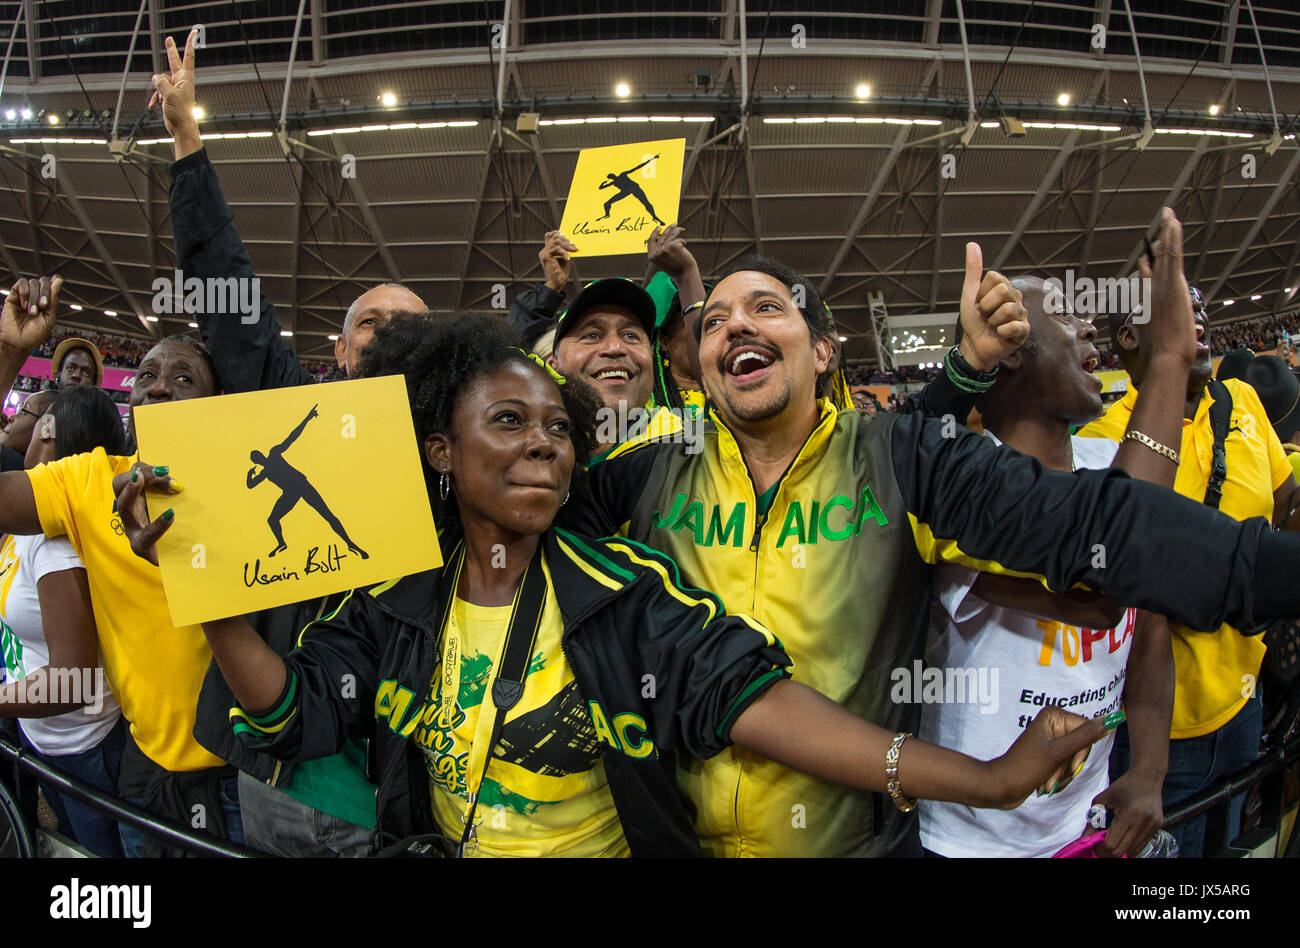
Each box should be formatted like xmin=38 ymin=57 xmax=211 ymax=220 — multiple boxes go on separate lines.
xmin=920 ymin=432 xmax=1136 ymax=857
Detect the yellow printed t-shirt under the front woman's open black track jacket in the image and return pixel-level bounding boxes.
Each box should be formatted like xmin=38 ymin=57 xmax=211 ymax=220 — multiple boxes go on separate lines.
xmin=413 ymin=584 xmax=628 ymax=857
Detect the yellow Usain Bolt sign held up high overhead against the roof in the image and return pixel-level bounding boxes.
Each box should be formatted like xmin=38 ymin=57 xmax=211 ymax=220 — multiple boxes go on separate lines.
xmin=560 ymin=138 xmax=686 ymax=256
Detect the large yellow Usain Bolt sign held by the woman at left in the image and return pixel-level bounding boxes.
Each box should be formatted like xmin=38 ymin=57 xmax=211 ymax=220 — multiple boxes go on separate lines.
xmin=135 ymin=376 xmax=442 ymax=625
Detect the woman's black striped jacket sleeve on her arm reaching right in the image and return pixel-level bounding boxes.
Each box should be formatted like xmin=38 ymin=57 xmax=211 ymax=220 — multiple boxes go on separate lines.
xmin=605 ymin=540 xmax=790 ymax=758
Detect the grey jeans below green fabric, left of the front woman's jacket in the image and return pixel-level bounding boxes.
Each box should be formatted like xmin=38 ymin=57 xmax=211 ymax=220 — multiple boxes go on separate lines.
xmin=239 ymin=774 xmax=371 ymax=858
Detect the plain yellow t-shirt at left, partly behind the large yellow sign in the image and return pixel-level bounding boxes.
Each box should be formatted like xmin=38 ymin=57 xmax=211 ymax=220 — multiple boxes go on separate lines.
xmin=27 ymin=447 xmax=225 ymax=771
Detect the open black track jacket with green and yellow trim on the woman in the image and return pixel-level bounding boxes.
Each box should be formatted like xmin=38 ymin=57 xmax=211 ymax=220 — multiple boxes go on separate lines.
xmin=230 ymin=529 xmax=789 ymax=856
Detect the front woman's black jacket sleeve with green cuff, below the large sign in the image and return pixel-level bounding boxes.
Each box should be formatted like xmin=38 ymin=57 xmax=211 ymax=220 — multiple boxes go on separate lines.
xmin=230 ymin=589 xmax=379 ymax=761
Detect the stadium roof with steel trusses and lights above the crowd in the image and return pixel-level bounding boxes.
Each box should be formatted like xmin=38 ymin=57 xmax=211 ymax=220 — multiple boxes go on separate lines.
xmin=0 ymin=0 xmax=1300 ymax=359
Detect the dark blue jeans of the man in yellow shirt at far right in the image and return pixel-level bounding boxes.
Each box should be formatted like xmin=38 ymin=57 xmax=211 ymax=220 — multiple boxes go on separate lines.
xmin=1110 ymin=692 xmax=1264 ymax=858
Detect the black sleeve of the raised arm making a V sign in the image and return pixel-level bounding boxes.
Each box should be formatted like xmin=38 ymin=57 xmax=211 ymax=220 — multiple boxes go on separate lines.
xmin=168 ymin=148 xmax=313 ymax=394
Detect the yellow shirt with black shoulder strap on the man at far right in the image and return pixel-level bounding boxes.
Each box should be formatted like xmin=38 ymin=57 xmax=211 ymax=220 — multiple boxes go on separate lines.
xmin=1079 ymin=378 xmax=1291 ymax=740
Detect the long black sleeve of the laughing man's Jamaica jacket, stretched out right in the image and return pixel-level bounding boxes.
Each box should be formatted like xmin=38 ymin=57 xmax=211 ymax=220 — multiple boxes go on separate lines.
xmin=891 ymin=415 xmax=1300 ymax=629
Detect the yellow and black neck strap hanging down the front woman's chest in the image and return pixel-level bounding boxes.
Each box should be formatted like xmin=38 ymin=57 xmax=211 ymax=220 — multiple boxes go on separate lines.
xmin=439 ymin=542 xmax=546 ymax=856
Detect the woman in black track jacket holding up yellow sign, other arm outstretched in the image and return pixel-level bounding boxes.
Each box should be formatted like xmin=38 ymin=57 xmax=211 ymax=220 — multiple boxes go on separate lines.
xmin=118 ymin=315 xmax=1105 ymax=856
